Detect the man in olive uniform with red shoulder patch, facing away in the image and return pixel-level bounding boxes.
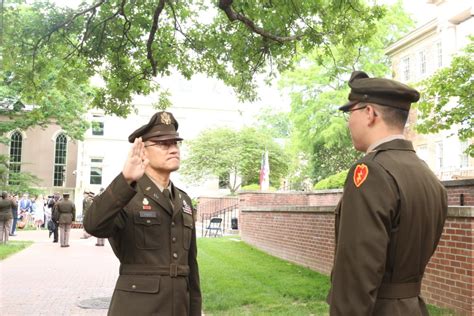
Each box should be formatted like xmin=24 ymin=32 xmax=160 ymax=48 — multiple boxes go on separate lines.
xmin=328 ymin=71 xmax=447 ymax=316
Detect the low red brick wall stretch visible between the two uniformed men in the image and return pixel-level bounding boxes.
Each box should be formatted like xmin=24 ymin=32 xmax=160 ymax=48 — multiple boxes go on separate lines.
xmin=240 ymin=206 xmax=334 ymax=274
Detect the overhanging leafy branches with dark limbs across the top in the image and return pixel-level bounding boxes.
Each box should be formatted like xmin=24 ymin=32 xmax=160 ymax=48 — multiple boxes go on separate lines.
xmin=0 ymin=0 xmax=384 ymax=123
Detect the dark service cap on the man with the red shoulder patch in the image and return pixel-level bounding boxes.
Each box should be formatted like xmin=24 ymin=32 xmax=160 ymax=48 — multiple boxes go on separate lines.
xmin=339 ymin=71 xmax=420 ymax=112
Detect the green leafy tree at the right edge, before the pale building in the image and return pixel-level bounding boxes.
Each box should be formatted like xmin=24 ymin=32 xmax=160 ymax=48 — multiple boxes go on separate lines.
xmin=416 ymin=36 xmax=474 ymax=157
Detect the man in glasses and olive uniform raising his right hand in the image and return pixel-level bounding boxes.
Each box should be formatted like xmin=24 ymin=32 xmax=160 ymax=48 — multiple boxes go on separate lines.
xmin=84 ymin=112 xmax=201 ymax=316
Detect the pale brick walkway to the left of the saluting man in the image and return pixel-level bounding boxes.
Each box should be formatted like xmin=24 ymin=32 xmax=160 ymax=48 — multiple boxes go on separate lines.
xmin=0 ymin=229 xmax=119 ymax=316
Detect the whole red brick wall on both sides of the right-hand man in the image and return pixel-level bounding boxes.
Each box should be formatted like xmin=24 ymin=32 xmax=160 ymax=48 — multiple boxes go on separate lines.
xmin=239 ymin=188 xmax=474 ymax=315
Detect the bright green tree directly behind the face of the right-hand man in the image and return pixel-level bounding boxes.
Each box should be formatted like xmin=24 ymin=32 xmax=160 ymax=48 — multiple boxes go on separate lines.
xmin=280 ymin=2 xmax=413 ymax=181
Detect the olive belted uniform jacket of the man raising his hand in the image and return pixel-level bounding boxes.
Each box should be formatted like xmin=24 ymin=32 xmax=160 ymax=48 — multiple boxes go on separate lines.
xmin=84 ymin=174 xmax=201 ymax=316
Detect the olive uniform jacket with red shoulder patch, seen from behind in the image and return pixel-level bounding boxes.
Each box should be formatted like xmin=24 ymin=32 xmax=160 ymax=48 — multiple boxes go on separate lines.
xmin=328 ymin=139 xmax=447 ymax=316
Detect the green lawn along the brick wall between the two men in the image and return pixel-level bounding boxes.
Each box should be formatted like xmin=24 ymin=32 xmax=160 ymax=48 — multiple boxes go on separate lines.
xmin=198 ymin=237 xmax=455 ymax=316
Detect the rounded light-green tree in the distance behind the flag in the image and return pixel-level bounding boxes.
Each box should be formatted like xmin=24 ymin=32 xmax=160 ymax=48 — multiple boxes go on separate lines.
xmin=180 ymin=127 xmax=288 ymax=193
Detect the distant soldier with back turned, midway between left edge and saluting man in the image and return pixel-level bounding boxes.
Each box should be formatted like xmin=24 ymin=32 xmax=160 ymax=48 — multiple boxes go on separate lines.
xmin=53 ymin=193 xmax=76 ymax=247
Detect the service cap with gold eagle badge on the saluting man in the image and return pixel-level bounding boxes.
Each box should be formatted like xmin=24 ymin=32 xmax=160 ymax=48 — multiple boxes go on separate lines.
xmin=128 ymin=111 xmax=183 ymax=143
